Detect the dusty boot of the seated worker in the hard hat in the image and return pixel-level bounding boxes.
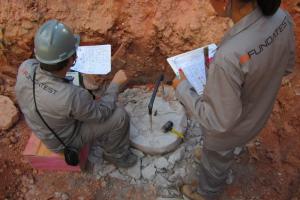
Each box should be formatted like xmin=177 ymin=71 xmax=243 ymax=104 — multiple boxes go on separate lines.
xmin=103 ymin=150 xmax=137 ymax=168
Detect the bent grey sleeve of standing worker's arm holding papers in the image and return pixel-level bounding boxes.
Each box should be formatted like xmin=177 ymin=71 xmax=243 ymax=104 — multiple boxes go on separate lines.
xmin=176 ymin=60 xmax=243 ymax=134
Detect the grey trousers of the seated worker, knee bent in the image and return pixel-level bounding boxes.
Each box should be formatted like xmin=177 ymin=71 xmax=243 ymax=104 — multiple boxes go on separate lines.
xmin=74 ymin=107 xmax=129 ymax=162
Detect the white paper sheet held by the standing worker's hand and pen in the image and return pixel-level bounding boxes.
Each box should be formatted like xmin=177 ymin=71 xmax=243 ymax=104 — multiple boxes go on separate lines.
xmin=167 ymin=44 xmax=217 ymax=95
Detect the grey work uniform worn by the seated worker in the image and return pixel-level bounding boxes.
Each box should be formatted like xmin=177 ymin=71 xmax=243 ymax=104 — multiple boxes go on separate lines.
xmin=15 ymin=59 xmax=129 ymax=161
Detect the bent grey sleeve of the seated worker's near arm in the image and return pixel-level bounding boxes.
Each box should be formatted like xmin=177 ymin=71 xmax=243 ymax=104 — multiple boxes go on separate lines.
xmin=70 ymin=83 xmax=119 ymax=123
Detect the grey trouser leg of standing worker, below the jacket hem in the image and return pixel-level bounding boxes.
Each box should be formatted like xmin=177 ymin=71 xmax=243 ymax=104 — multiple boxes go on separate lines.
xmin=198 ymin=147 xmax=234 ymax=199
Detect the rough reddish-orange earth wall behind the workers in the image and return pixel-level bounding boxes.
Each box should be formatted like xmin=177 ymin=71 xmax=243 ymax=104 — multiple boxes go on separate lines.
xmin=0 ymin=0 xmax=229 ymax=82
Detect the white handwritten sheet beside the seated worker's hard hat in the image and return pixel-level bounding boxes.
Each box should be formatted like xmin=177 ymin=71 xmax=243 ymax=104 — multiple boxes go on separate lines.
xmin=71 ymin=45 xmax=111 ymax=75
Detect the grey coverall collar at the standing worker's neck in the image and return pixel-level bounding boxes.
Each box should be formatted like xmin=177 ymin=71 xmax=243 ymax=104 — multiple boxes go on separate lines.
xmin=220 ymin=8 xmax=263 ymax=46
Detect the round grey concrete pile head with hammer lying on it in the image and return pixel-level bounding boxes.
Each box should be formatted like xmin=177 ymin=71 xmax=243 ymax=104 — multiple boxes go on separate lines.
xmin=121 ymin=87 xmax=187 ymax=154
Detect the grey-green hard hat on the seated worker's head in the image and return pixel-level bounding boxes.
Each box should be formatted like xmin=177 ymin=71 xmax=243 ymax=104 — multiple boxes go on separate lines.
xmin=34 ymin=20 xmax=80 ymax=65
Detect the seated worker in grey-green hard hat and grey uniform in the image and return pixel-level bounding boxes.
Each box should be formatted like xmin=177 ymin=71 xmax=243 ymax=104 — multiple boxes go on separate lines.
xmin=15 ymin=20 xmax=137 ymax=168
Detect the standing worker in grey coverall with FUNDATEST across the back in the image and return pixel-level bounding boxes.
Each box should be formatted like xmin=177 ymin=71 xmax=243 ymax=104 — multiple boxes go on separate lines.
xmin=173 ymin=0 xmax=295 ymax=200
